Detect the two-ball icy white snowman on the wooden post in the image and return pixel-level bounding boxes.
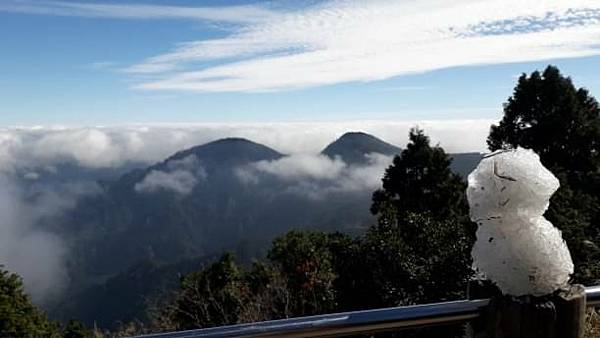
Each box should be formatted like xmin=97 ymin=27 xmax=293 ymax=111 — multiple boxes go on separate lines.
xmin=467 ymin=148 xmax=573 ymax=296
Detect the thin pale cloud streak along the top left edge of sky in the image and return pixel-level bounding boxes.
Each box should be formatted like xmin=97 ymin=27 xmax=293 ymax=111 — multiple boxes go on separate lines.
xmin=0 ymin=0 xmax=274 ymax=23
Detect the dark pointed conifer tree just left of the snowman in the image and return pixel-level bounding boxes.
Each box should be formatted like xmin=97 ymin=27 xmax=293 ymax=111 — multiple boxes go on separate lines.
xmin=360 ymin=128 xmax=475 ymax=337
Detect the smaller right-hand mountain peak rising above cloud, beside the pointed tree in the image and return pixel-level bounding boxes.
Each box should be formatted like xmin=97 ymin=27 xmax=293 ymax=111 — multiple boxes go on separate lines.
xmin=321 ymin=131 xmax=401 ymax=163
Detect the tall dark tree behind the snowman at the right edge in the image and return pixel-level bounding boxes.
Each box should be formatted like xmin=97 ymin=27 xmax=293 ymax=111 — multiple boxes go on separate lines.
xmin=488 ymin=66 xmax=600 ymax=284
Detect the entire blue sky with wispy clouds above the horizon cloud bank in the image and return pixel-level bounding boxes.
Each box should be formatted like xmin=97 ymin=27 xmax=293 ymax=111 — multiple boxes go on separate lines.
xmin=0 ymin=0 xmax=600 ymax=125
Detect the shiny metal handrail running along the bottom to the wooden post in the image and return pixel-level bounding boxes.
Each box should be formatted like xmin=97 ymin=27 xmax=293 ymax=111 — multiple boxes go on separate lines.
xmin=140 ymin=285 xmax=600 ymax=338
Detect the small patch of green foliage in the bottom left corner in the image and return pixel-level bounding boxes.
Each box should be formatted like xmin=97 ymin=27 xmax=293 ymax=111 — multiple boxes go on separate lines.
xmin=0 ymin=266 xmax=60 ymax=337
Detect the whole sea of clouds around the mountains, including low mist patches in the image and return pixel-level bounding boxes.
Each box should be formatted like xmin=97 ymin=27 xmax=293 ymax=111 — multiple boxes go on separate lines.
xmin=0 ymin=120 xmax=493 ymax=303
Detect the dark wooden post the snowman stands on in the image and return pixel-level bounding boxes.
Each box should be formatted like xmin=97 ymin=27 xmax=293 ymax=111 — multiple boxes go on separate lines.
xmin=468 ymin=281 xmax=585 ymax=338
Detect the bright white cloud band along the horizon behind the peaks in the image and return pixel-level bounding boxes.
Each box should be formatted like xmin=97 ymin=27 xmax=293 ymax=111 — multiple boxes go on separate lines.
xmin=0 ymin=119 xmax=490 ymax=175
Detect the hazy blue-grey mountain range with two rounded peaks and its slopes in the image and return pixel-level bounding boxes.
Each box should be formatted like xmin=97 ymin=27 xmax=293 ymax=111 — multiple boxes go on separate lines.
xmin=51 ymin=132 xmax=481 ymax=325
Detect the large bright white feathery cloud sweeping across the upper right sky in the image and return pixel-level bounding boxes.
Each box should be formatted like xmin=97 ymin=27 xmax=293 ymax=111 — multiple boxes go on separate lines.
xmin=128 ymin=0 xmax=600 ymax=92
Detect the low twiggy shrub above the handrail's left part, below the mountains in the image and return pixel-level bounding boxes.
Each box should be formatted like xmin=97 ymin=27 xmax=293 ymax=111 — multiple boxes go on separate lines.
xmin=154 ymin=253 xmax=292 ymax=330
